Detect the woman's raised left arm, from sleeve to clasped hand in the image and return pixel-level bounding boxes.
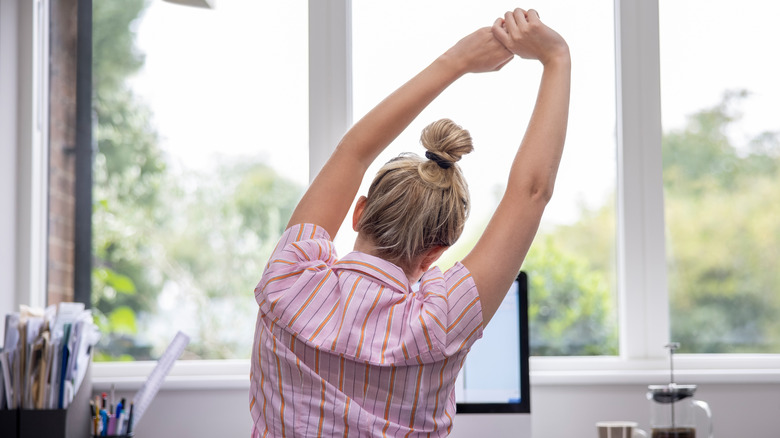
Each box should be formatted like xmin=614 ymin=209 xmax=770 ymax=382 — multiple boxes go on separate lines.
xmin=288 ymin=27 xmax=512 ymax=238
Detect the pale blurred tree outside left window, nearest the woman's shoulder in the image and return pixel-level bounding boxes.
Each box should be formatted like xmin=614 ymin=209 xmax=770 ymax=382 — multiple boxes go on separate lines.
xmin=151 ymin=162 xmax=302 ymax=359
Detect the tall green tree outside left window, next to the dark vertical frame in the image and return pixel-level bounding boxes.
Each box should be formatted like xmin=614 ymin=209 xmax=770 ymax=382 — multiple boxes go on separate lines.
xmin=92 ymin=0 xmax=165 ymax=360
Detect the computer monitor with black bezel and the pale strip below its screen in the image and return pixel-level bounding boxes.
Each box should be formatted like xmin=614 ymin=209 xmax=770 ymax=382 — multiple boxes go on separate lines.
xmin=451 ymin=272 xmax=531 ymax=437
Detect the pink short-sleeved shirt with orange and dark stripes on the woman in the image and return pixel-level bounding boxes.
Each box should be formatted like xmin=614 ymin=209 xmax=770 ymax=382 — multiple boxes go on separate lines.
xmin=249 ymin=224 xmax=482 ymax=437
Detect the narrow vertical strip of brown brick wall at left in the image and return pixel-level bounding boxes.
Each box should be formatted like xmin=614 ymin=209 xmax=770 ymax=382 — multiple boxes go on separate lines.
xmin=47 ymin=0 xmax=77 ymax=304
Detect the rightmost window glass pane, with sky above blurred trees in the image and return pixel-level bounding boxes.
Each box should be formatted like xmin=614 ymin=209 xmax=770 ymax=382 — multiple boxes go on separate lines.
xmin=659 ymin=0 xmax=780 ymax=353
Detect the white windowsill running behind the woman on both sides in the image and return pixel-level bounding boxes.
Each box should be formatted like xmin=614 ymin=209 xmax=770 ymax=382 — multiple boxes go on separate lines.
xmin=92 ymin=355 xmax=780 ymax=391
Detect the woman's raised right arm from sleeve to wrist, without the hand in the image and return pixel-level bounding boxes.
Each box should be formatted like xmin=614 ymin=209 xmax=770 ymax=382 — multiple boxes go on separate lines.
xmin=463 ymin=52 xmax=571 ymax=323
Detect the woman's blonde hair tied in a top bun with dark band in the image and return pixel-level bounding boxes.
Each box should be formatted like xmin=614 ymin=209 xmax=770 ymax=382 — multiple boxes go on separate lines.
xmin=357 ymin=119 xmax=474 ymax=270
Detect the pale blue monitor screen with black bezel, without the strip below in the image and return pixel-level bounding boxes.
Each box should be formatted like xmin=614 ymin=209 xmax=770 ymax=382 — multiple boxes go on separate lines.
xmin=455 ymin=272 xmax=531 ymax=414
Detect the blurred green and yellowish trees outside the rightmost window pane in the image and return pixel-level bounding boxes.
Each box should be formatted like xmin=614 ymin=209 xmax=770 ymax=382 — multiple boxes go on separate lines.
xmin=663 ymin=91 xmax=780 ymax=353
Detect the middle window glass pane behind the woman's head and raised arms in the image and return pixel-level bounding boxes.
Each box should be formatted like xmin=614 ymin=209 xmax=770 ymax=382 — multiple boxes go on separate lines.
xmin=350 ymin=0 xmax=618 ymax=355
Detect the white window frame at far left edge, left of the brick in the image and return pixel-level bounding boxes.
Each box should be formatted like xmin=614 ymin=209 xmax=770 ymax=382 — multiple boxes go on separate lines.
xmin=0 ymin=0 xmax=49 ymax=315
